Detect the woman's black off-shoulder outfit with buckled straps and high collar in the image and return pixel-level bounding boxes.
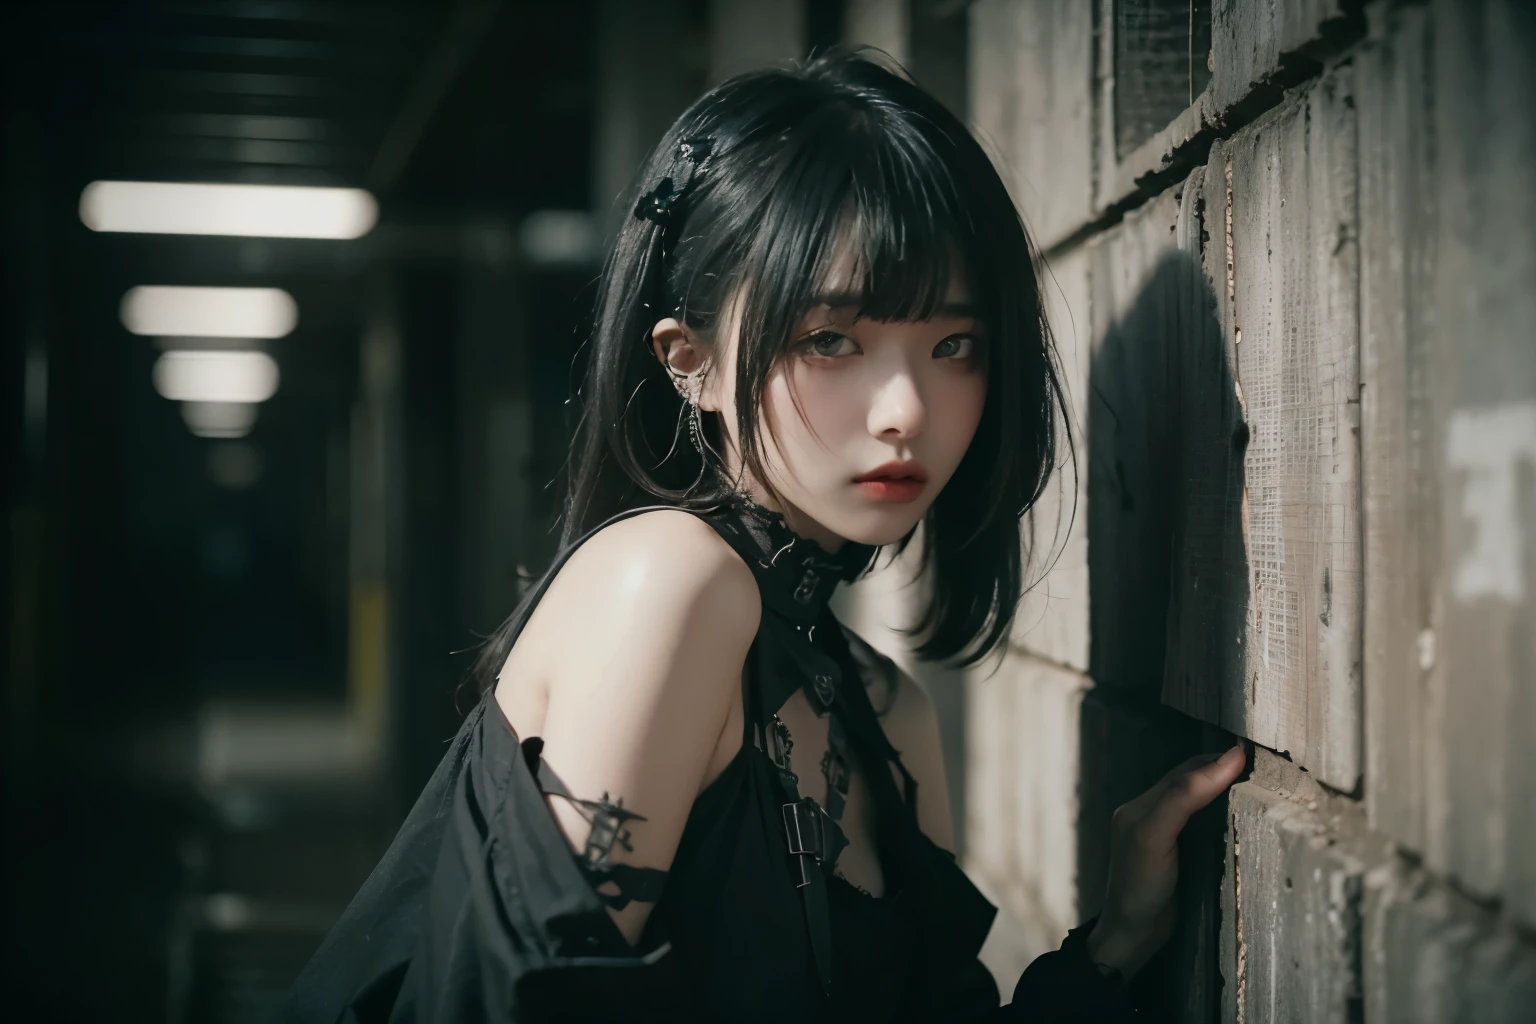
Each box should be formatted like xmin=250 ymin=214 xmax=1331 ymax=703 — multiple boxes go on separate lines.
xmin=286 ymin=500 xmax=1134 ymax=1024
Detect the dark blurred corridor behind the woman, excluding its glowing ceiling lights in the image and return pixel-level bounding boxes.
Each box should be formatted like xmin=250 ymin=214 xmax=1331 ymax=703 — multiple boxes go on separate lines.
xmin=0 ymin=0 xmax=866 ymax=1021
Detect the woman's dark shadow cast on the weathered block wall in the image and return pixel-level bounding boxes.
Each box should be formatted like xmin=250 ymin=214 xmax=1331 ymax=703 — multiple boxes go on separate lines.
xmin=1078 ymin=242 xmax=1249 ymax=1019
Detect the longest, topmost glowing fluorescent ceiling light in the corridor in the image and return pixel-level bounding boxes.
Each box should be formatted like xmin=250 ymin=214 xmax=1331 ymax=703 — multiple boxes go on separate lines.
xmin=80 ymin=181 xmax=379 ymax=238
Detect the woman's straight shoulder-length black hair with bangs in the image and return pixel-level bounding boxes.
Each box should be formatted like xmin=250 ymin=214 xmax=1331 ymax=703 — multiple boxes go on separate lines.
xmin=476 ymin=44 xmax=1066 ymax=685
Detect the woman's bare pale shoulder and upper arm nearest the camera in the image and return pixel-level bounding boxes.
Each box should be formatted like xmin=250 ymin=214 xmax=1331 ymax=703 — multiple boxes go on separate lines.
xmin=498 ymin=511 xmax=762 ymax=944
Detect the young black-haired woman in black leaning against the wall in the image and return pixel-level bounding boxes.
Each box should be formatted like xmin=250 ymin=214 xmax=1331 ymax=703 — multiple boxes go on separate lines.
xmin=290 ymin=55 xmax=1243 ymax=1021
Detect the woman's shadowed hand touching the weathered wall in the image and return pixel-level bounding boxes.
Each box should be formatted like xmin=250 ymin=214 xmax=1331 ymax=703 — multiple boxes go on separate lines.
xmin=1087 ymin=745 xmax=1246 ymax=979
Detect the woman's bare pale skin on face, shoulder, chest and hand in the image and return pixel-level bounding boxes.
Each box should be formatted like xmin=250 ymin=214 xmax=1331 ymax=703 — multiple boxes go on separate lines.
xmin=496 ymin=260 xmax=1244 ymax=976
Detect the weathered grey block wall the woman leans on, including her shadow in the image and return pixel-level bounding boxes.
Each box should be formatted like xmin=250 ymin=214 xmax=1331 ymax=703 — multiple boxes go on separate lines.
xmin=965 ymin=0 xmax=1536 ymax=1022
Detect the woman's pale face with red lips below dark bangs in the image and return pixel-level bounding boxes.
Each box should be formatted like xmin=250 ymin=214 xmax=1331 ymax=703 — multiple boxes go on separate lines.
xmin=678 ymin=264 xmax=986 ymax=550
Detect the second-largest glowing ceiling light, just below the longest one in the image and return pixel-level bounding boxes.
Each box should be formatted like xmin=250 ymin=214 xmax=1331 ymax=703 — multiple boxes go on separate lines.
xmin=118 ymin=286 xmax=298 ymax=338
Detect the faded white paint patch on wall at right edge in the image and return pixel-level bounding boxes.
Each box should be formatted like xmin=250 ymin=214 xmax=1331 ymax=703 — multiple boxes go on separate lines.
xmin=1445 ymin=401 xmax=1536 ymax=603
